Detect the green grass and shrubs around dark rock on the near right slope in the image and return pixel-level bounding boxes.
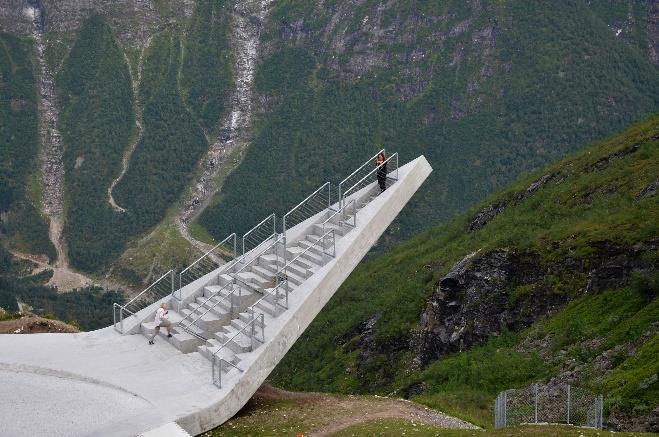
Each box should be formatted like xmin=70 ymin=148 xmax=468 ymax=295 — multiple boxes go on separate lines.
xmin=273 ymin=116 xmax=659 ymax=426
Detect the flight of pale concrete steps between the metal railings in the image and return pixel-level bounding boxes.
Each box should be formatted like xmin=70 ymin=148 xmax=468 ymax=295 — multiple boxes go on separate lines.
xmin=141 ymin=186 xmax=380 ymax=373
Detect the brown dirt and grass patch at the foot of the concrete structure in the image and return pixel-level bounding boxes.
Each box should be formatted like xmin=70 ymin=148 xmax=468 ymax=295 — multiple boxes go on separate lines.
xmin=223 ymin=384 xmax=478 ymax=437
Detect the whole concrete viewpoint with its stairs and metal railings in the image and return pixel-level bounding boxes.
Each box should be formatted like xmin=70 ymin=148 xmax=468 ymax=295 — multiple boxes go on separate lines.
xmin=0 ymin=153 xmax=432 ymax=437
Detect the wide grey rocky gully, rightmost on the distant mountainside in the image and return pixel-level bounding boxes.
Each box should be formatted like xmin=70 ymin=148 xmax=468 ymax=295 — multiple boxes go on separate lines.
xmin=175 ymin=0 xmax=273 ymax=251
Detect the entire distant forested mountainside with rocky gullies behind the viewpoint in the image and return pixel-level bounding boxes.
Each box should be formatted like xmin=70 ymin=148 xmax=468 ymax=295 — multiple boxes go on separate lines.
xmin=0 ymin=0 xmax=659 ymax=282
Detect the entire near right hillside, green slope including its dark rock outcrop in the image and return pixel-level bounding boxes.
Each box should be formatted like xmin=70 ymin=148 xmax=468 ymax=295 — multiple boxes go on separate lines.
xmin=273 ymin=115 xmax=659 ymax=432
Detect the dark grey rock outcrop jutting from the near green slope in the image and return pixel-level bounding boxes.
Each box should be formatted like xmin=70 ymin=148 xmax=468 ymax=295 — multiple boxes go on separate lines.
xmin=411 ymin=240 xmax=659 ymax=365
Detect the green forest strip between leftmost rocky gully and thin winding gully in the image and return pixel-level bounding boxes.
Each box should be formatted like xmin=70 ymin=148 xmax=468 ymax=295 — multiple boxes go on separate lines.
xmin=57 ymin=16 xmax=135 ymax=271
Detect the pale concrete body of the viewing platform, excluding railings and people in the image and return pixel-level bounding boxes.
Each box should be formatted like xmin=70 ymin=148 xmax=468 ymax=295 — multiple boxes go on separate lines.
xmin=0 ymin=156 xmax=432 ymax=437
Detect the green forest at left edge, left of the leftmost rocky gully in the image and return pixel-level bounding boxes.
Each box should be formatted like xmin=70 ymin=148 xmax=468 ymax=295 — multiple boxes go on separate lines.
xmin=0 ymin=32 xmax=55 ymax=259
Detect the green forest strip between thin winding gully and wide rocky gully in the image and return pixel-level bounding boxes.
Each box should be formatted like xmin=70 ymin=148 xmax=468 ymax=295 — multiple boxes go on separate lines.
xmin=115 ymin=32 xmax=208 ymax=238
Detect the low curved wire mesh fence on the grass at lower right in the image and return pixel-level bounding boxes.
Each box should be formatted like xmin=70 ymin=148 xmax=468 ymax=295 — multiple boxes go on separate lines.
xmin=494 ymin=384 xmax=604 ymax=429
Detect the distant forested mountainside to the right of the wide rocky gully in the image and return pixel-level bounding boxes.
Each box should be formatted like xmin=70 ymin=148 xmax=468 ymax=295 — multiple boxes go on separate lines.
xmin=200 ymin=0 xmax=659 ymax=242
